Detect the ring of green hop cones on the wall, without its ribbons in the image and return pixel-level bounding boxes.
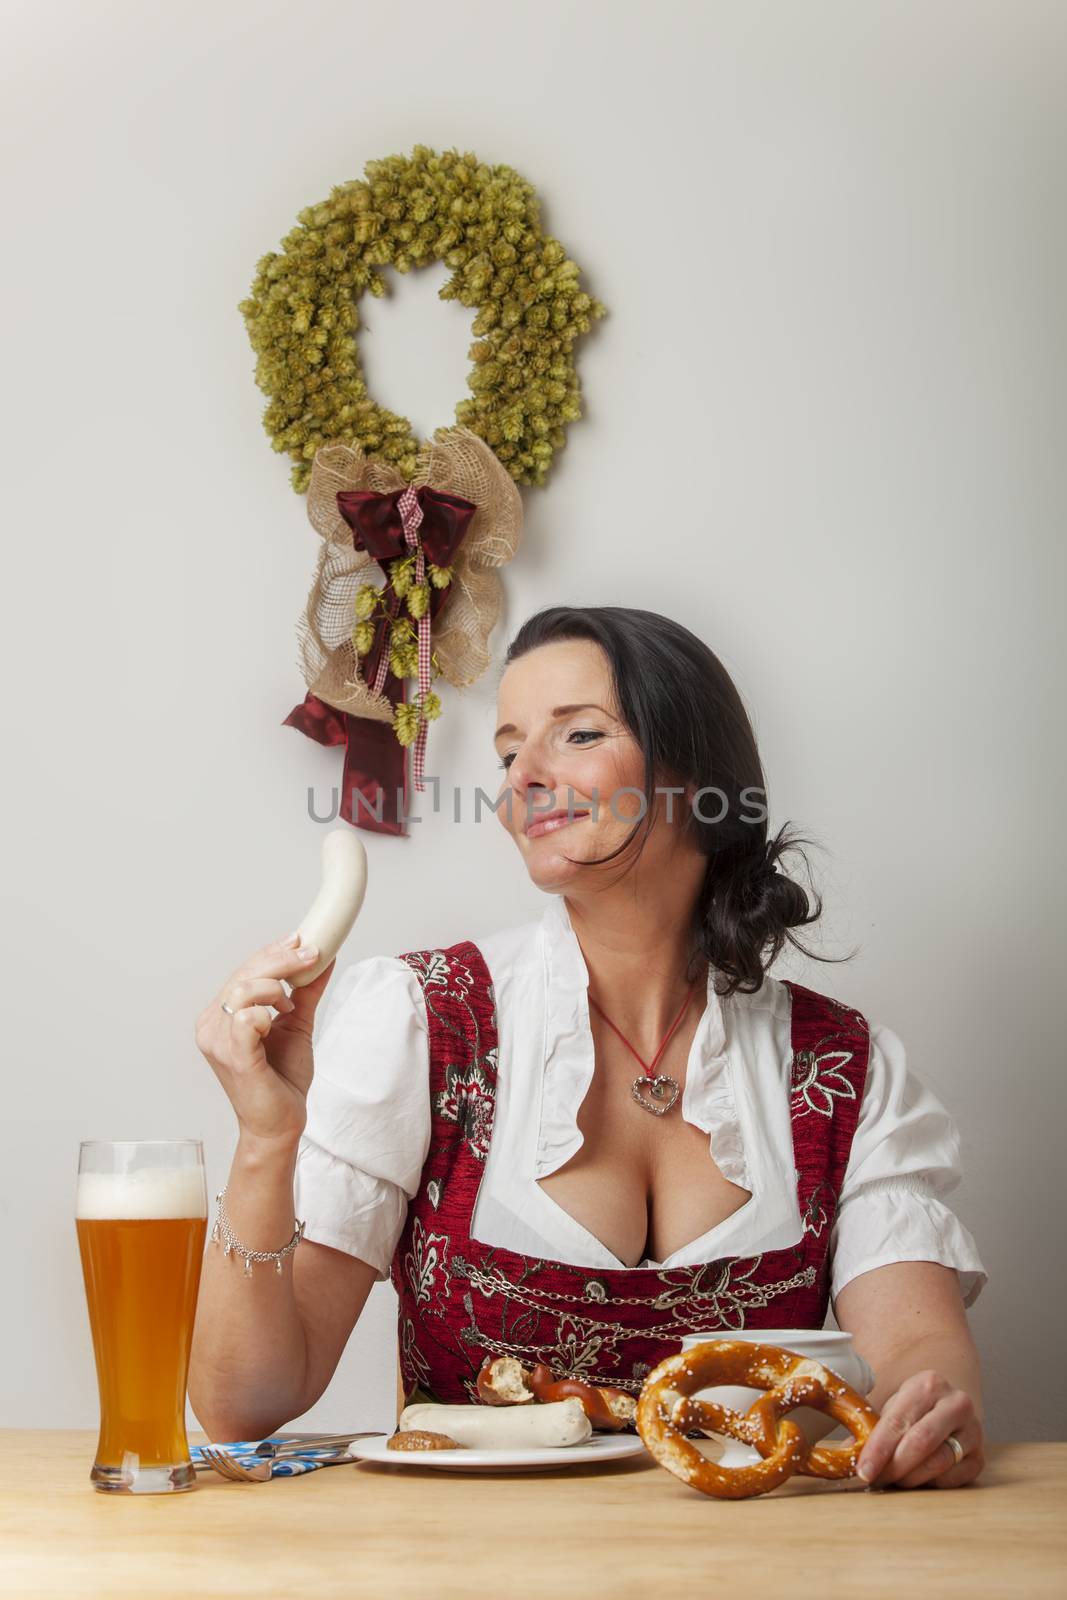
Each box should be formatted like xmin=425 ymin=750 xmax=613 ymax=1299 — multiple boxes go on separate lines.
xmin=240 ymin=144 xmax=605 ymax=491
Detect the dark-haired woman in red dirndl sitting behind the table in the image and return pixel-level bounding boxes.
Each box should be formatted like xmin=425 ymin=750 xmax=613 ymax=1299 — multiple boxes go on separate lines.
xmin=190 ymin=606 xmax=984 ymax=1488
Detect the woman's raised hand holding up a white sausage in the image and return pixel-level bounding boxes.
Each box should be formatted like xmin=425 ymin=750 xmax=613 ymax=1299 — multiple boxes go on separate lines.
xmin=197 ymin=933 xmax=333 ymax=1144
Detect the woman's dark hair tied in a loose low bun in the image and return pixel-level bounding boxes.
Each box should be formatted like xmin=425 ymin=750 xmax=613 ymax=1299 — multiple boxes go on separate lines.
xmin=504 ymin=605 xmax=843 ymax=995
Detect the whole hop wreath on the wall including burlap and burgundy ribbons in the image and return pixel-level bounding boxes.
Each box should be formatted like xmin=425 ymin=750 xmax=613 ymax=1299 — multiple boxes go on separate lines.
xmin=240 ymin=146 xmax=605 ymax=832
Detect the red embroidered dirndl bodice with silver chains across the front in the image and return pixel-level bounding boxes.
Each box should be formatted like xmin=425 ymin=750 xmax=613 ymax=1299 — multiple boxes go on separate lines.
xmin=390 ymin=941 xmax=870 ymax=1403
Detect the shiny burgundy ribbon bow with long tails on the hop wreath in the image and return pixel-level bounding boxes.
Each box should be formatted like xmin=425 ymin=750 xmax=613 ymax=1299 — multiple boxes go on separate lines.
xmin=285 ymin=485 xmax=477 ymax=834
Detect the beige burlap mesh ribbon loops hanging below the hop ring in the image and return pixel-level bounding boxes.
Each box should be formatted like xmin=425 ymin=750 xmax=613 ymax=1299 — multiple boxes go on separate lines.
xmin=298 ymin=427 xmax=523 ymax=722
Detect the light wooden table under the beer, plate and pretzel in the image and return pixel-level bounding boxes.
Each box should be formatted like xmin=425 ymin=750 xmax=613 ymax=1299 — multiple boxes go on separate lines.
xmin=0 ymin=1432 xmax=1067 ymax=1600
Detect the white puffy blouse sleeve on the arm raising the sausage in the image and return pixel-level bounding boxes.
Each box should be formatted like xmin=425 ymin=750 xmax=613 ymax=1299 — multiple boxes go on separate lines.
xmin=294 ymin=955 xmax=430 ymax=1278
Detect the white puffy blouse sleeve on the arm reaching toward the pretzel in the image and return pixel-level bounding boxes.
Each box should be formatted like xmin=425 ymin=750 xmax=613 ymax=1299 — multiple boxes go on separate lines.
xmin=830 ymin=1024 xmax=987 ymax=1306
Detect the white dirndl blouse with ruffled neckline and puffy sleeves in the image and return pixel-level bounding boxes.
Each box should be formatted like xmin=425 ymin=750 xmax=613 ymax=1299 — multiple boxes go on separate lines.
xmin=296 ymin=894 xmax=985 ymax=1306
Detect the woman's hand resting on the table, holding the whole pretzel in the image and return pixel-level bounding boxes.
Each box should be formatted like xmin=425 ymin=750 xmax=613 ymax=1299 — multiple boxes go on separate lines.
xmin=857 ymin=1371 xmax=985 ymax=1490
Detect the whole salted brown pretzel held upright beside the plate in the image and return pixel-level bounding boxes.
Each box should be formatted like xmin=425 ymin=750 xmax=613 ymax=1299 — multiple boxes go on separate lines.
xmin=637 ymin=1339 xmax=878 ymax=1499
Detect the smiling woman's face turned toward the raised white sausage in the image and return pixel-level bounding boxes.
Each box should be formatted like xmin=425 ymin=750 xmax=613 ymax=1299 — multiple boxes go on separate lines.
xmin=496 ymin=638 xmax=694 ymax=890
